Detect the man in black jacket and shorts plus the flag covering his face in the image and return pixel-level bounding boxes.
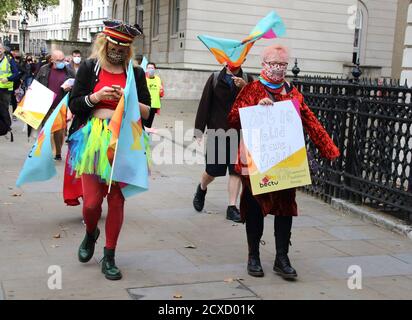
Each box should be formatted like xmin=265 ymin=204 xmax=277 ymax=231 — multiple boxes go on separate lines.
xmin=193 ymin=11 xmax=285 ymax=222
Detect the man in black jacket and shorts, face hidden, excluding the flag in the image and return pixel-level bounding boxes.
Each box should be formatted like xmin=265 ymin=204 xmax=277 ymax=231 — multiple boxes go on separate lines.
xmin=193 ymin=64 xmax=253 ymax=222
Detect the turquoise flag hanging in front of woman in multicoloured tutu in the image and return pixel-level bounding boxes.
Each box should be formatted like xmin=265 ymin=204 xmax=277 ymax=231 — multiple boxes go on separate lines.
xmin=109 ymin=62 xmax=149 ymax=197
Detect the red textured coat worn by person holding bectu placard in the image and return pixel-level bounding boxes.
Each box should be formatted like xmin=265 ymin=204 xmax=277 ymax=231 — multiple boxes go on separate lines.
xmin=228 ymin=80 xmax=340 ymax=221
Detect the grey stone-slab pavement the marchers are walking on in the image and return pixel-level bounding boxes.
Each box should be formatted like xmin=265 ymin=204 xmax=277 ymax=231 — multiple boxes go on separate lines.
xmin=0 ymin=101 xmax=412 ymax=300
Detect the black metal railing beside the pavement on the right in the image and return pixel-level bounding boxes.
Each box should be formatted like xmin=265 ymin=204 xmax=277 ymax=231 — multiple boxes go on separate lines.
xmin=293 ymin=59 xmax=412 ymax=221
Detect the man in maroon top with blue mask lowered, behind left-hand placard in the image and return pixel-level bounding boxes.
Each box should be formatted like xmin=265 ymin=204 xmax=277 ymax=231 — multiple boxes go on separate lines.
xmin=36 ymin=50 xmax=75 ymax=160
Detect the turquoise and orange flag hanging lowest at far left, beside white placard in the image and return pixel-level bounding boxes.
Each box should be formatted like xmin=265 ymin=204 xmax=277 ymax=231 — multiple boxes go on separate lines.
xmin=16 ymin=94 xmax=69 ymax=187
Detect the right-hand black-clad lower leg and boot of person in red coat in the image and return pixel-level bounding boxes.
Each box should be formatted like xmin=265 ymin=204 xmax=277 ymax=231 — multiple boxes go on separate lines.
xmin=273 ymin=217 xmax=298 ymax=279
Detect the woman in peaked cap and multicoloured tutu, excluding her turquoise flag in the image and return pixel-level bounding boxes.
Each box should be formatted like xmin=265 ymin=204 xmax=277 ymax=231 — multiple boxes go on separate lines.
xmin=64 ymin=20 xmax=151 ymax=280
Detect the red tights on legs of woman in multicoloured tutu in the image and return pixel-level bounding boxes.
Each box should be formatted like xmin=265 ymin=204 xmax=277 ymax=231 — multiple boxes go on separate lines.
xmin=82 ymin=174 xmax=124 ymax=249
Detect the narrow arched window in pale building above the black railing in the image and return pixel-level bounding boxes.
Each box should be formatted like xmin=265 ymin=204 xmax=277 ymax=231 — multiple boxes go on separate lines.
xmin=353 ymin=1 xmax=368 ymax=64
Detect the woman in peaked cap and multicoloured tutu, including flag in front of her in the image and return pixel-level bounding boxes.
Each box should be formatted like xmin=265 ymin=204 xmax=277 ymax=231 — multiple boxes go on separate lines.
xmin=63 ymin=20 xmax=151 ymax=280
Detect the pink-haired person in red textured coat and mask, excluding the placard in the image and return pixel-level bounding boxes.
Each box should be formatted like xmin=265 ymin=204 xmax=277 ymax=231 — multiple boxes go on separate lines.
xmin=228 ymin=45 xmax=340 ymax=278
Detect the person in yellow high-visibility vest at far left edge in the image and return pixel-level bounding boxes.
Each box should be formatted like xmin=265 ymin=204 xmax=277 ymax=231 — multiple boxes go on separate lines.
xmin=0 ymin=44 xmax=19 ymax=131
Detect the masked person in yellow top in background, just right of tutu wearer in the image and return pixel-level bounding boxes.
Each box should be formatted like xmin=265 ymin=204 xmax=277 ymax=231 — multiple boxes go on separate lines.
xmin=144 ymin=62 xmax=164 ymax=131
